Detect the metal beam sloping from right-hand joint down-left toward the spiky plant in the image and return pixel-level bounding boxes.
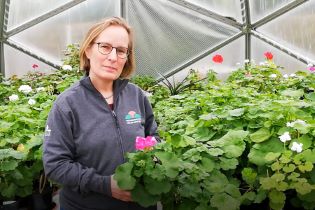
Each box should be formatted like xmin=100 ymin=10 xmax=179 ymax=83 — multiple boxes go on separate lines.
xmin=159 ymin=32 xmax=244 ymax=78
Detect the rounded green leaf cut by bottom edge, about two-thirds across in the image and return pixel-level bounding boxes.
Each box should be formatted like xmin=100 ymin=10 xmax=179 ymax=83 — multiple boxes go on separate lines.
xmin=210 ymin=193 xmax=241 ymax=210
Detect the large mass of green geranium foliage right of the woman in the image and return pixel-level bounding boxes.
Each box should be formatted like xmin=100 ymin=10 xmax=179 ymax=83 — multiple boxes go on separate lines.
xmin=115 ymin=61 xmax=315 ymax=210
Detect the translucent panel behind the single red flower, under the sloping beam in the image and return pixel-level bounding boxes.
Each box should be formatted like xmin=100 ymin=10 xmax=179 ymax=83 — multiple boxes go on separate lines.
xmin=174 ymin=36 xmax=245 ymax=80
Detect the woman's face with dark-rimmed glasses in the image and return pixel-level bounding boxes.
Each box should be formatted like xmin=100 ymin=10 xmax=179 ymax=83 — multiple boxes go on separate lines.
xmin=85 ymin=25 xmax=129 ymax=81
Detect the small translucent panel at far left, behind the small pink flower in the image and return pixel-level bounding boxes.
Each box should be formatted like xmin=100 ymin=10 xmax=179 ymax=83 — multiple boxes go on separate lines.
xmin=4 ymin=45 xmax=54 ymax=78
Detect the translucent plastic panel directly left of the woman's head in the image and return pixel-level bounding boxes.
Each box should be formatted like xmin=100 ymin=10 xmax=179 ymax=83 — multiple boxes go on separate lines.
xmin=11 ymin=0 xmax=120 ymax=64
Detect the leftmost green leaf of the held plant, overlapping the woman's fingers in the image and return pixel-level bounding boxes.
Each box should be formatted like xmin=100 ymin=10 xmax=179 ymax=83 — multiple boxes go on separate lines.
xmin=114 ymin=162 xmax=136 ymax=190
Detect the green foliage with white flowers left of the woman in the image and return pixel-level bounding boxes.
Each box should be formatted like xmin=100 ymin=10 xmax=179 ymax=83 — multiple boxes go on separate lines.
xmin=0 ymin=55 xmax=82 ymax=200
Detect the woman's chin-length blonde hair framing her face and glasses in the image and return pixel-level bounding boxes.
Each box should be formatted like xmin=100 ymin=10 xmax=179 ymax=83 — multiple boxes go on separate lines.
xmin=80 ymin=17 xmax=135 ymax=78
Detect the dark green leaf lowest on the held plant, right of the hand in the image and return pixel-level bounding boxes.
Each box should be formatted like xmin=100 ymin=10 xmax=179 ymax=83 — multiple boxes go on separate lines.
xmin=131 ymin=183 xmax=160 ymax=207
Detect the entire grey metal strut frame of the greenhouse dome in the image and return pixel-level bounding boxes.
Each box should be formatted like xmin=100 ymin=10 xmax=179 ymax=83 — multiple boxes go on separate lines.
xmin=0 ymin=0 xmax=315 ymax=77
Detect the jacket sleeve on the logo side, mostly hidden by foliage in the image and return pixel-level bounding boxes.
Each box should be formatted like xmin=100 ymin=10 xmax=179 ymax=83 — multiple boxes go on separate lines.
xmin=144 ymin=96 xmax=161 ymax=142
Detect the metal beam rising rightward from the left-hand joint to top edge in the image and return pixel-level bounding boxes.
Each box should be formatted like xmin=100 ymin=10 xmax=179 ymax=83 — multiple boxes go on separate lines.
xmin=7 ymin=0 xmax=86 ymax=37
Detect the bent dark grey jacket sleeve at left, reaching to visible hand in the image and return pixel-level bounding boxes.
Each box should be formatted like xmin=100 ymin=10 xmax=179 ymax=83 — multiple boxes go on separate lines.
xmin=43 ymin=103 xmax=111 ymax=196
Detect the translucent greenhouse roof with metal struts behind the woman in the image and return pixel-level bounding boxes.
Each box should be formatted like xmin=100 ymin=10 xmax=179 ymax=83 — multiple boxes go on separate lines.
xmin=0 ymin=0 xmax=315 ymax=77
